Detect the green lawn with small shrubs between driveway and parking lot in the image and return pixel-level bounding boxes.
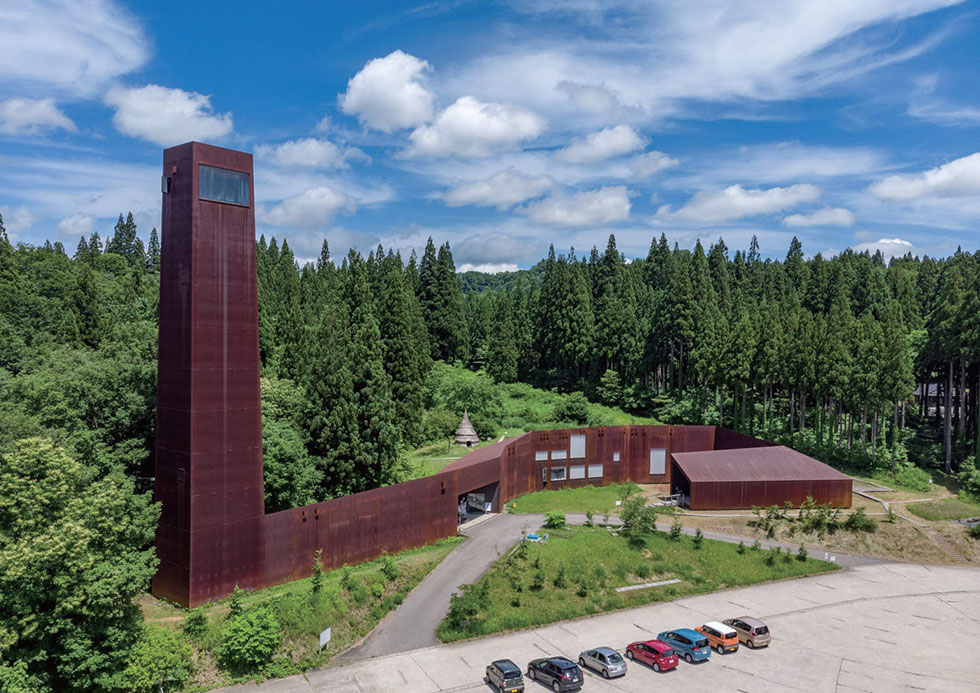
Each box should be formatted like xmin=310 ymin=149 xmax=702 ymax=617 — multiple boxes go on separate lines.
xmin=438 ymin=527 xmax=837 ymax=642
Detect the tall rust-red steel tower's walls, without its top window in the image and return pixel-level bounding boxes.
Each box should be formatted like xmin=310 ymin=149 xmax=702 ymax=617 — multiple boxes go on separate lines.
xmin=153 ymin=143 xmax=264 ymax=604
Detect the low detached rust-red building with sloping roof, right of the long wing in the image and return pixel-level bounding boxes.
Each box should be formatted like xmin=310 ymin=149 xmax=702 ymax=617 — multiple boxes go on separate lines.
xmin=671 ymin=445 xmax=851 ymax=510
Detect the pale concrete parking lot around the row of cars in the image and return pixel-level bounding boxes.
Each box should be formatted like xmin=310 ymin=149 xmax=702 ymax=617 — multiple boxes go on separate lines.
xmin=226 ymin=563 xmax=980 ymax=693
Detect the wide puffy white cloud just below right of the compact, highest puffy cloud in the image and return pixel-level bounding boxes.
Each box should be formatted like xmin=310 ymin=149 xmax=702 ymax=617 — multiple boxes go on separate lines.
xmin=409 ymin=96 xmax=545 ymax=158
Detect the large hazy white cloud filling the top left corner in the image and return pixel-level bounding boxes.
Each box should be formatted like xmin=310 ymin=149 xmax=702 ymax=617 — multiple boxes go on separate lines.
xmin=0 ymin=0 xmax=150 ymax=96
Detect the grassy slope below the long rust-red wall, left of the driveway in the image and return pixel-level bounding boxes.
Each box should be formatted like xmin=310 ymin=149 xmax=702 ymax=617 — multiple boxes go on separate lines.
xmin=140 ymin=537 xmax=462 ymax=691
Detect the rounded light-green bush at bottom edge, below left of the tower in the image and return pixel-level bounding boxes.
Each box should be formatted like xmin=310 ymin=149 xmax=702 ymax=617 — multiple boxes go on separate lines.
xmin=123 ymin=628 xmax=192 ymax=693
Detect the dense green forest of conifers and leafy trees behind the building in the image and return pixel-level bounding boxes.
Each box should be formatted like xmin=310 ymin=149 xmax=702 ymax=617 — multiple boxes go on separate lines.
xmin=0 ymin=208 xmax=980 ymax=690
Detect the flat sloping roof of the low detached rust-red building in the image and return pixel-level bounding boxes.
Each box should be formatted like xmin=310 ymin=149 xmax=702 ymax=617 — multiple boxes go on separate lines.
xmin=671 ymin=445 xmax=850 ymax=482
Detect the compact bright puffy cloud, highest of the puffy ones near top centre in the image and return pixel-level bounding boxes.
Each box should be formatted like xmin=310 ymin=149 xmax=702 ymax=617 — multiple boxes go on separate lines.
xmin=338 ymin=51 xmax=435 ymax=132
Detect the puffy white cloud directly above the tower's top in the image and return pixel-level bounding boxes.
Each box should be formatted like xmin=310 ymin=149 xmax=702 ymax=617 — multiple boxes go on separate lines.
xmin=105 ymin=84 xmax=233 ymax=147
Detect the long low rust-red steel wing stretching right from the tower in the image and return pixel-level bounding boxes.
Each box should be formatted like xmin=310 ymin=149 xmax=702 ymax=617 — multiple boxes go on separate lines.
xmin=163 ymin=426 xmax=769 ymax=605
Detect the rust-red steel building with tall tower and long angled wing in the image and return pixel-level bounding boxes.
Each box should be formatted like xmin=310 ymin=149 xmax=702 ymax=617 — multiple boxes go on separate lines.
xmin=152 ymin=143 xmax=850 ymax=606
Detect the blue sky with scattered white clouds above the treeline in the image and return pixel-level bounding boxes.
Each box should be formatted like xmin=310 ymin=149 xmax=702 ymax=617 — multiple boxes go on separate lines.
xmin=0 ymin=0 xmax=980 ymax=271
